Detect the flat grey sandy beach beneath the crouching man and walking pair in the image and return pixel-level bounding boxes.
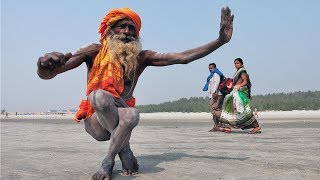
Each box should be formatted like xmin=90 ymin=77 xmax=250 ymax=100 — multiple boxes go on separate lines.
xmin=1 ymin=111 xmax=320 ymax=180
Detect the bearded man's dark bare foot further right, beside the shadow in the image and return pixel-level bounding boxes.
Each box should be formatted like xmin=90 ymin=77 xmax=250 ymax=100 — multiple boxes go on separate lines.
xmin=119 ymin=145 xmax=139 ymax=175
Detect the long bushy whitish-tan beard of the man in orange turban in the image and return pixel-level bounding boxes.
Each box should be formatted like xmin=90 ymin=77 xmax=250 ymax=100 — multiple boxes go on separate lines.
xmin=107 ymin=34 xmax=141 ymax=79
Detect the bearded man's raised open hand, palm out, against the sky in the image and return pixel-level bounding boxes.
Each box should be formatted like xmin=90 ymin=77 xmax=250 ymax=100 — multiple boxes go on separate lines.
xmin=219 ymin=7 xmax=234 ymax=43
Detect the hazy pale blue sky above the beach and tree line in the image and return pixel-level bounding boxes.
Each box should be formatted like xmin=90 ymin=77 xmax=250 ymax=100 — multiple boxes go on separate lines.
xmin=1 ymin=0 xmax=320 ymax=112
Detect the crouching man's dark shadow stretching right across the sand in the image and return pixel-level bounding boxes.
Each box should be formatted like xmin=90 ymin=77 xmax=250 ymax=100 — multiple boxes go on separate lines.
xmin=113 ymin=152 xmax=249 ymax=179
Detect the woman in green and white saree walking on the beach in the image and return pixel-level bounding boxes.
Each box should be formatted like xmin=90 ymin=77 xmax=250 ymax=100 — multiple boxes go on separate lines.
xmin=221 ymin=58 xmax=261 ymax=134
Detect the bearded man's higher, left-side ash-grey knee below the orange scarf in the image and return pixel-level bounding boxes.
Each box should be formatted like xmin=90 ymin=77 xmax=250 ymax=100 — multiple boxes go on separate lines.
xmin=89 ymin=89 xmax=114 ymax=111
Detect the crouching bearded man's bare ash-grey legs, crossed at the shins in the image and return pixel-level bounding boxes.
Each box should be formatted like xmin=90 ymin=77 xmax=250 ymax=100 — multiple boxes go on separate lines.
xmin=86 ymin=90 xmax=139 ymax=179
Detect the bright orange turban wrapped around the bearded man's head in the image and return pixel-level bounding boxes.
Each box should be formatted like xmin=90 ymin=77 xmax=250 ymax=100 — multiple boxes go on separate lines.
xmin=98 ymin=8 xmax=141 ymax=38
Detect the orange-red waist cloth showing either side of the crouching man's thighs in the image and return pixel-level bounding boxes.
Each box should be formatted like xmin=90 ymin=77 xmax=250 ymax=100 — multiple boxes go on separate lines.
xmin=74 ymin=97 xmax=136 ymax=122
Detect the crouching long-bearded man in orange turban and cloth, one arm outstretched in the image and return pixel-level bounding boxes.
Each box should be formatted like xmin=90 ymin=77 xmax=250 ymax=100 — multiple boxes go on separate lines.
xmin=37 ymin=7 xmax=233 ymax=179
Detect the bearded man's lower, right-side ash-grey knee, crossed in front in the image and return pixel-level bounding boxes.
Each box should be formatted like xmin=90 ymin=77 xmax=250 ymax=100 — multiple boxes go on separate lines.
xmin=119 ymin=108 xmax=139 ymax=129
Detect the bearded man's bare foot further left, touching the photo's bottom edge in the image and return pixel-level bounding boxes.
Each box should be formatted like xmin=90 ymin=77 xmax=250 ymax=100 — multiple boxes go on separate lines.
xmin=91 ymin=159 xmax=114 ymax=180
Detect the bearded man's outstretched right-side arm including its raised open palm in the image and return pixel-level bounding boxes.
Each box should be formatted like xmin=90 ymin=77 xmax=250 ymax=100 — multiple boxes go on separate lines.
xmin=142 ymin=7 xmax=234 ymax=66
